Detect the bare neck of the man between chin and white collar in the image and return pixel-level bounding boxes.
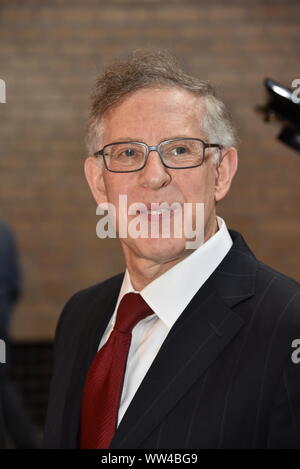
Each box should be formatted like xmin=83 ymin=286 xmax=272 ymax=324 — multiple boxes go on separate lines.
xmin=122 ymin=218 xmax=218 ymax=291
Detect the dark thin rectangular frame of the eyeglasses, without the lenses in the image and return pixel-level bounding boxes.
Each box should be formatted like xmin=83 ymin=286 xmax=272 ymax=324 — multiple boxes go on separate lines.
xmin=94 ymin=137 xmax=224 ymax=173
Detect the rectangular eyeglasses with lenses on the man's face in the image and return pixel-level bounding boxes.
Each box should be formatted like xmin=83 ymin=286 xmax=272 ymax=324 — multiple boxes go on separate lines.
xmin=94 ymin=138 xmax=223 ymax=173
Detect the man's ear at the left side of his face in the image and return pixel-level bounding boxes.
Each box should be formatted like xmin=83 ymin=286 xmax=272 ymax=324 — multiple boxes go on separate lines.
xmin=84 ymin=156 xmax=107 ymax=205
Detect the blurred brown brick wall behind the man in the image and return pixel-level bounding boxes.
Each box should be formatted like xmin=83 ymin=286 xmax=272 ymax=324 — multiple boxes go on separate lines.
xmin=0 ymin=0 xmax=300 ymax=340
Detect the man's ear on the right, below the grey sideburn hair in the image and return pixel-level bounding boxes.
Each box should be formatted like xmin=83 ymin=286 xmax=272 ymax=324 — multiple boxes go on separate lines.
xmin=215 ymin=147 xmax=238 ymax=202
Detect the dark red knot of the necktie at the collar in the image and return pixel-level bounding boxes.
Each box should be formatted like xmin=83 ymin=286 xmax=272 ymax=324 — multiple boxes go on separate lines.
xmin=114 ymin=293 xmax=154 ymax=332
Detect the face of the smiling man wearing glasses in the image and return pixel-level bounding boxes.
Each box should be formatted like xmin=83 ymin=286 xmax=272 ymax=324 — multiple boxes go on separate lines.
xmin=92 ymin=88 xmax=223 ymax=263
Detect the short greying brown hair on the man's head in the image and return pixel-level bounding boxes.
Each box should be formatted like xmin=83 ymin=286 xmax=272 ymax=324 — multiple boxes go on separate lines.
xmin=86 ymin=50 xmax=237 ymax=163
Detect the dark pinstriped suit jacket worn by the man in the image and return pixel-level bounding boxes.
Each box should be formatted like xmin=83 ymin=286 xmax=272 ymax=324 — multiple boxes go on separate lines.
xmin=45 ymin=230 xmax=300 ymax=449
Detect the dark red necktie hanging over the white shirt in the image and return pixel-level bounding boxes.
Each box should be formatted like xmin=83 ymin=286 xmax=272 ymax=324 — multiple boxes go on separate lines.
xmin=79 ymin=293 xmax=154 ymax=449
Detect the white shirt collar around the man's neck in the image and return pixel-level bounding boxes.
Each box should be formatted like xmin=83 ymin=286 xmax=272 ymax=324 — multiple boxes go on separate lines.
xmin=116 ymin=216 xmax=233 ymax=329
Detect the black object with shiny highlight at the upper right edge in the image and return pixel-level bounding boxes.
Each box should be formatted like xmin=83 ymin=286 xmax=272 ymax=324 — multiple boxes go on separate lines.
xmin=257 ymin=78 xmax=300 ymax=152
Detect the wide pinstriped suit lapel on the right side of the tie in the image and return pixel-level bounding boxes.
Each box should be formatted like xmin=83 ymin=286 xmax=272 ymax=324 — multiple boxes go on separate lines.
xmin=110 ymin=231 xmax=257 ymax=448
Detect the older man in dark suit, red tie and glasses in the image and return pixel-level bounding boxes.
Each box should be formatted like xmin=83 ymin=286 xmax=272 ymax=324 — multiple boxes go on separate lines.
xmin=45 ymin=52 xmax=300 ymax=449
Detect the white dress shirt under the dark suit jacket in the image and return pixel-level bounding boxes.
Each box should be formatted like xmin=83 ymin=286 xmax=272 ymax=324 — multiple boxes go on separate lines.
xmin=99 ymin=216 xmax=232 ymax=425
